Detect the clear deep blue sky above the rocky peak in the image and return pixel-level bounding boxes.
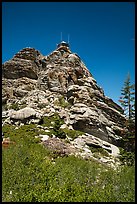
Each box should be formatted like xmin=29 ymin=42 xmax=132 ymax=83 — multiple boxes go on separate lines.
xmin=2 ymin=2 xmax=135 ymax=103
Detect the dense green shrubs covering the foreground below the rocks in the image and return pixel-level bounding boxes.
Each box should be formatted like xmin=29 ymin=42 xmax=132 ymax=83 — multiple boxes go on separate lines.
xmin=2 ymin=124 xmax=135 ymax=202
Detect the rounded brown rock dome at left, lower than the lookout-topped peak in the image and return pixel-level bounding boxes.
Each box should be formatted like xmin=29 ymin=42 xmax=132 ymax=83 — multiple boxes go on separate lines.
xmin=2 ymin=48 xmax=42 ymax=79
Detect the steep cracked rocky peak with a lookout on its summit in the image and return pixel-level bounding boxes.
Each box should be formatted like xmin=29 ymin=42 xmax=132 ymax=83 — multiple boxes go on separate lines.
xmin=2 ymin=44 xmax=126 ymax=145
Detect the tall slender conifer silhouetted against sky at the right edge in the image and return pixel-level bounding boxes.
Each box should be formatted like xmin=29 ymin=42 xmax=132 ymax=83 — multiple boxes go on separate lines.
xmin=119 ymin=73 xmax=135 ymax=121
